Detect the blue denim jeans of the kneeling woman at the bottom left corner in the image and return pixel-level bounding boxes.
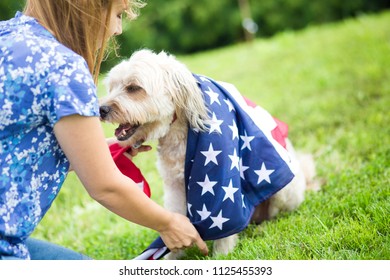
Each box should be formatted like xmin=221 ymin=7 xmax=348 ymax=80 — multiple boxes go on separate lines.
xmin=0 ymin=238 xmax=91 ymax=260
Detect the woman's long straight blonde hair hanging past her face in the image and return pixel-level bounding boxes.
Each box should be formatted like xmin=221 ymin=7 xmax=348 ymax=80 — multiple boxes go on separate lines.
xmin=24 ymin=0 xmax=145 ymax=83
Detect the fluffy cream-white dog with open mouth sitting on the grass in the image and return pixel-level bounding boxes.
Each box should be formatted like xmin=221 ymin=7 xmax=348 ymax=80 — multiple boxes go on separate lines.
xmin=100 ymin=50 xmax=316 ymax=258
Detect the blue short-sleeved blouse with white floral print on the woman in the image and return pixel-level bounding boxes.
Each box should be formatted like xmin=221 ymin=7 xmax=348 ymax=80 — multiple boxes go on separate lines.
xmin=0 ymin=12 xmax=99 ymax=259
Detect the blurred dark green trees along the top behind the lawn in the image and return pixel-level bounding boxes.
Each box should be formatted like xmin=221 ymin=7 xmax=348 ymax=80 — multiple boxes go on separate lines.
xmin=0 ymin=0 xmax=390 ymax=71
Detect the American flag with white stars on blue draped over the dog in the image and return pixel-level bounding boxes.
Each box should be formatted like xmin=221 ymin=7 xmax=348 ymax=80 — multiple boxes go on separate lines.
xmin=135 ymin=75 xmax=294 ymax=260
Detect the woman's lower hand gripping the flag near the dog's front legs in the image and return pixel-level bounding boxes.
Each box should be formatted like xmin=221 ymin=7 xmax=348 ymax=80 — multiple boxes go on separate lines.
xmin=159 ymin=213 xmax=208 ymax=256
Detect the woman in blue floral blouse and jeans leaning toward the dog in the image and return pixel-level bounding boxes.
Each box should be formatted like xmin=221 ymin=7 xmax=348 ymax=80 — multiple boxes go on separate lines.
xmin=0 ymin=0 xmax=207 ymax=259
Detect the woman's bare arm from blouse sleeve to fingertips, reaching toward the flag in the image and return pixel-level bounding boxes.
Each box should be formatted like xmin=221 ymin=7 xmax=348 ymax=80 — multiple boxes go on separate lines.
xmin=54 ymin=115 xmax=208 ymax=254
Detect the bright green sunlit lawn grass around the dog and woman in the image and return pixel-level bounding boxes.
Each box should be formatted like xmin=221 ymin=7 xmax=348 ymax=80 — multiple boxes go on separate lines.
xmin=34 ymin=12 xmax=390 ymax=260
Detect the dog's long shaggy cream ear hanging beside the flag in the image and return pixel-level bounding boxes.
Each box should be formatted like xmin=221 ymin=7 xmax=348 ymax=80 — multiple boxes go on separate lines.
xmin=159 ymin=52 xmax=209 ymax=131
